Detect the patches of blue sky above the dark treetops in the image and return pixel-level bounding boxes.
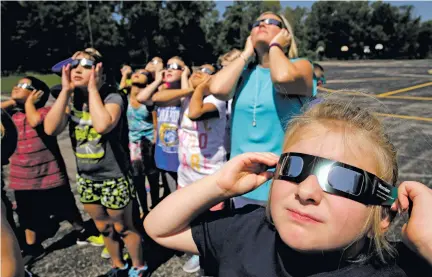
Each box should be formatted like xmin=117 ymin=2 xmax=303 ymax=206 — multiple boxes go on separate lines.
xmin=216 ymin=1 xmax=432 ymax=21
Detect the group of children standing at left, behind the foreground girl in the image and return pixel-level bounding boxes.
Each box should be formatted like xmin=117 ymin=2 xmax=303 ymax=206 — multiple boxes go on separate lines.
xmin=1 ymin=48 xmax=253 ymax=276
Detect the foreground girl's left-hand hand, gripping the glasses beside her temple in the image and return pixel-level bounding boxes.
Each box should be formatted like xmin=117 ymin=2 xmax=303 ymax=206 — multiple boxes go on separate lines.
xmin=216 ymin=152 xmax=279 ymax=197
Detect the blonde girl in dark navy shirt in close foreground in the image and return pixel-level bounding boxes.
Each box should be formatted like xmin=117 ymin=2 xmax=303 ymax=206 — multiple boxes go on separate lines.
xmin=144 ymin=102 xmax=432 ymax=277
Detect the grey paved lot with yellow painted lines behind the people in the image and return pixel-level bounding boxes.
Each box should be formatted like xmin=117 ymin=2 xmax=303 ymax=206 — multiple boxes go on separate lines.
xmin=2 ymin=60 xmax=432 ymax=277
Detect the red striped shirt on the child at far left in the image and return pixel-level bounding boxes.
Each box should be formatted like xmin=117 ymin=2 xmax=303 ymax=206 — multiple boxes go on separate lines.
xmin=9 ymin=107 xmax=67 ymax=190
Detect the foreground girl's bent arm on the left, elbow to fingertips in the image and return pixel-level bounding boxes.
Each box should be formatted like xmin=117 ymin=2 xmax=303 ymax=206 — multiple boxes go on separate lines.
xmin=144 ymin=153 xmax=278 ymax=254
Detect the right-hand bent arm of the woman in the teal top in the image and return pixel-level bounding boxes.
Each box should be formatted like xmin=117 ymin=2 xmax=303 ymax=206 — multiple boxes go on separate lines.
xmin=269 ymin=29 xmax=313 ymax=96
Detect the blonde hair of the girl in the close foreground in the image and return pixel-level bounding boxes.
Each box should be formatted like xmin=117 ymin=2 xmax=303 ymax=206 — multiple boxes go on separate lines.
xmin=266 ymin=99 xmax=398 ymax=263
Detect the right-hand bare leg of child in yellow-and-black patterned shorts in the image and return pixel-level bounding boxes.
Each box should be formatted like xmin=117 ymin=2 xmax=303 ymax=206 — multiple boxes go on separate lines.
xmin=107 ymin=201 xmax=145 ymax=267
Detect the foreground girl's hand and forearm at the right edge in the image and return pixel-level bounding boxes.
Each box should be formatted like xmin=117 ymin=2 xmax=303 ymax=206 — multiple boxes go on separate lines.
xmin=391 ymin=181 xmax=432 ymax=264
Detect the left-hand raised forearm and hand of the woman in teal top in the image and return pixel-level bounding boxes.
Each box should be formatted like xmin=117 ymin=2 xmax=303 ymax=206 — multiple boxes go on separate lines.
xmin=210 ymin=37 xmax=254 ymax=101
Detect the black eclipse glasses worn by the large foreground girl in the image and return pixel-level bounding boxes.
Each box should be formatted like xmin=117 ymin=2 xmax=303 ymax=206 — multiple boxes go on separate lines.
xmin=275 ymin=152 xmax=397 ymax=206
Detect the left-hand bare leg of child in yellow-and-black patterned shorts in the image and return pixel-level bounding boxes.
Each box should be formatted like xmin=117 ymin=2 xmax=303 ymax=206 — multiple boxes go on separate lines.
xmin=84 ymin=204 xmax=124 ymax=268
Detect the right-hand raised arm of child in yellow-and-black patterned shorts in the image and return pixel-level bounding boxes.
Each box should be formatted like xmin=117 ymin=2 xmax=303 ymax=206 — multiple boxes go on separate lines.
xmin=87 ymin=63 xmax=121 ymax=135
